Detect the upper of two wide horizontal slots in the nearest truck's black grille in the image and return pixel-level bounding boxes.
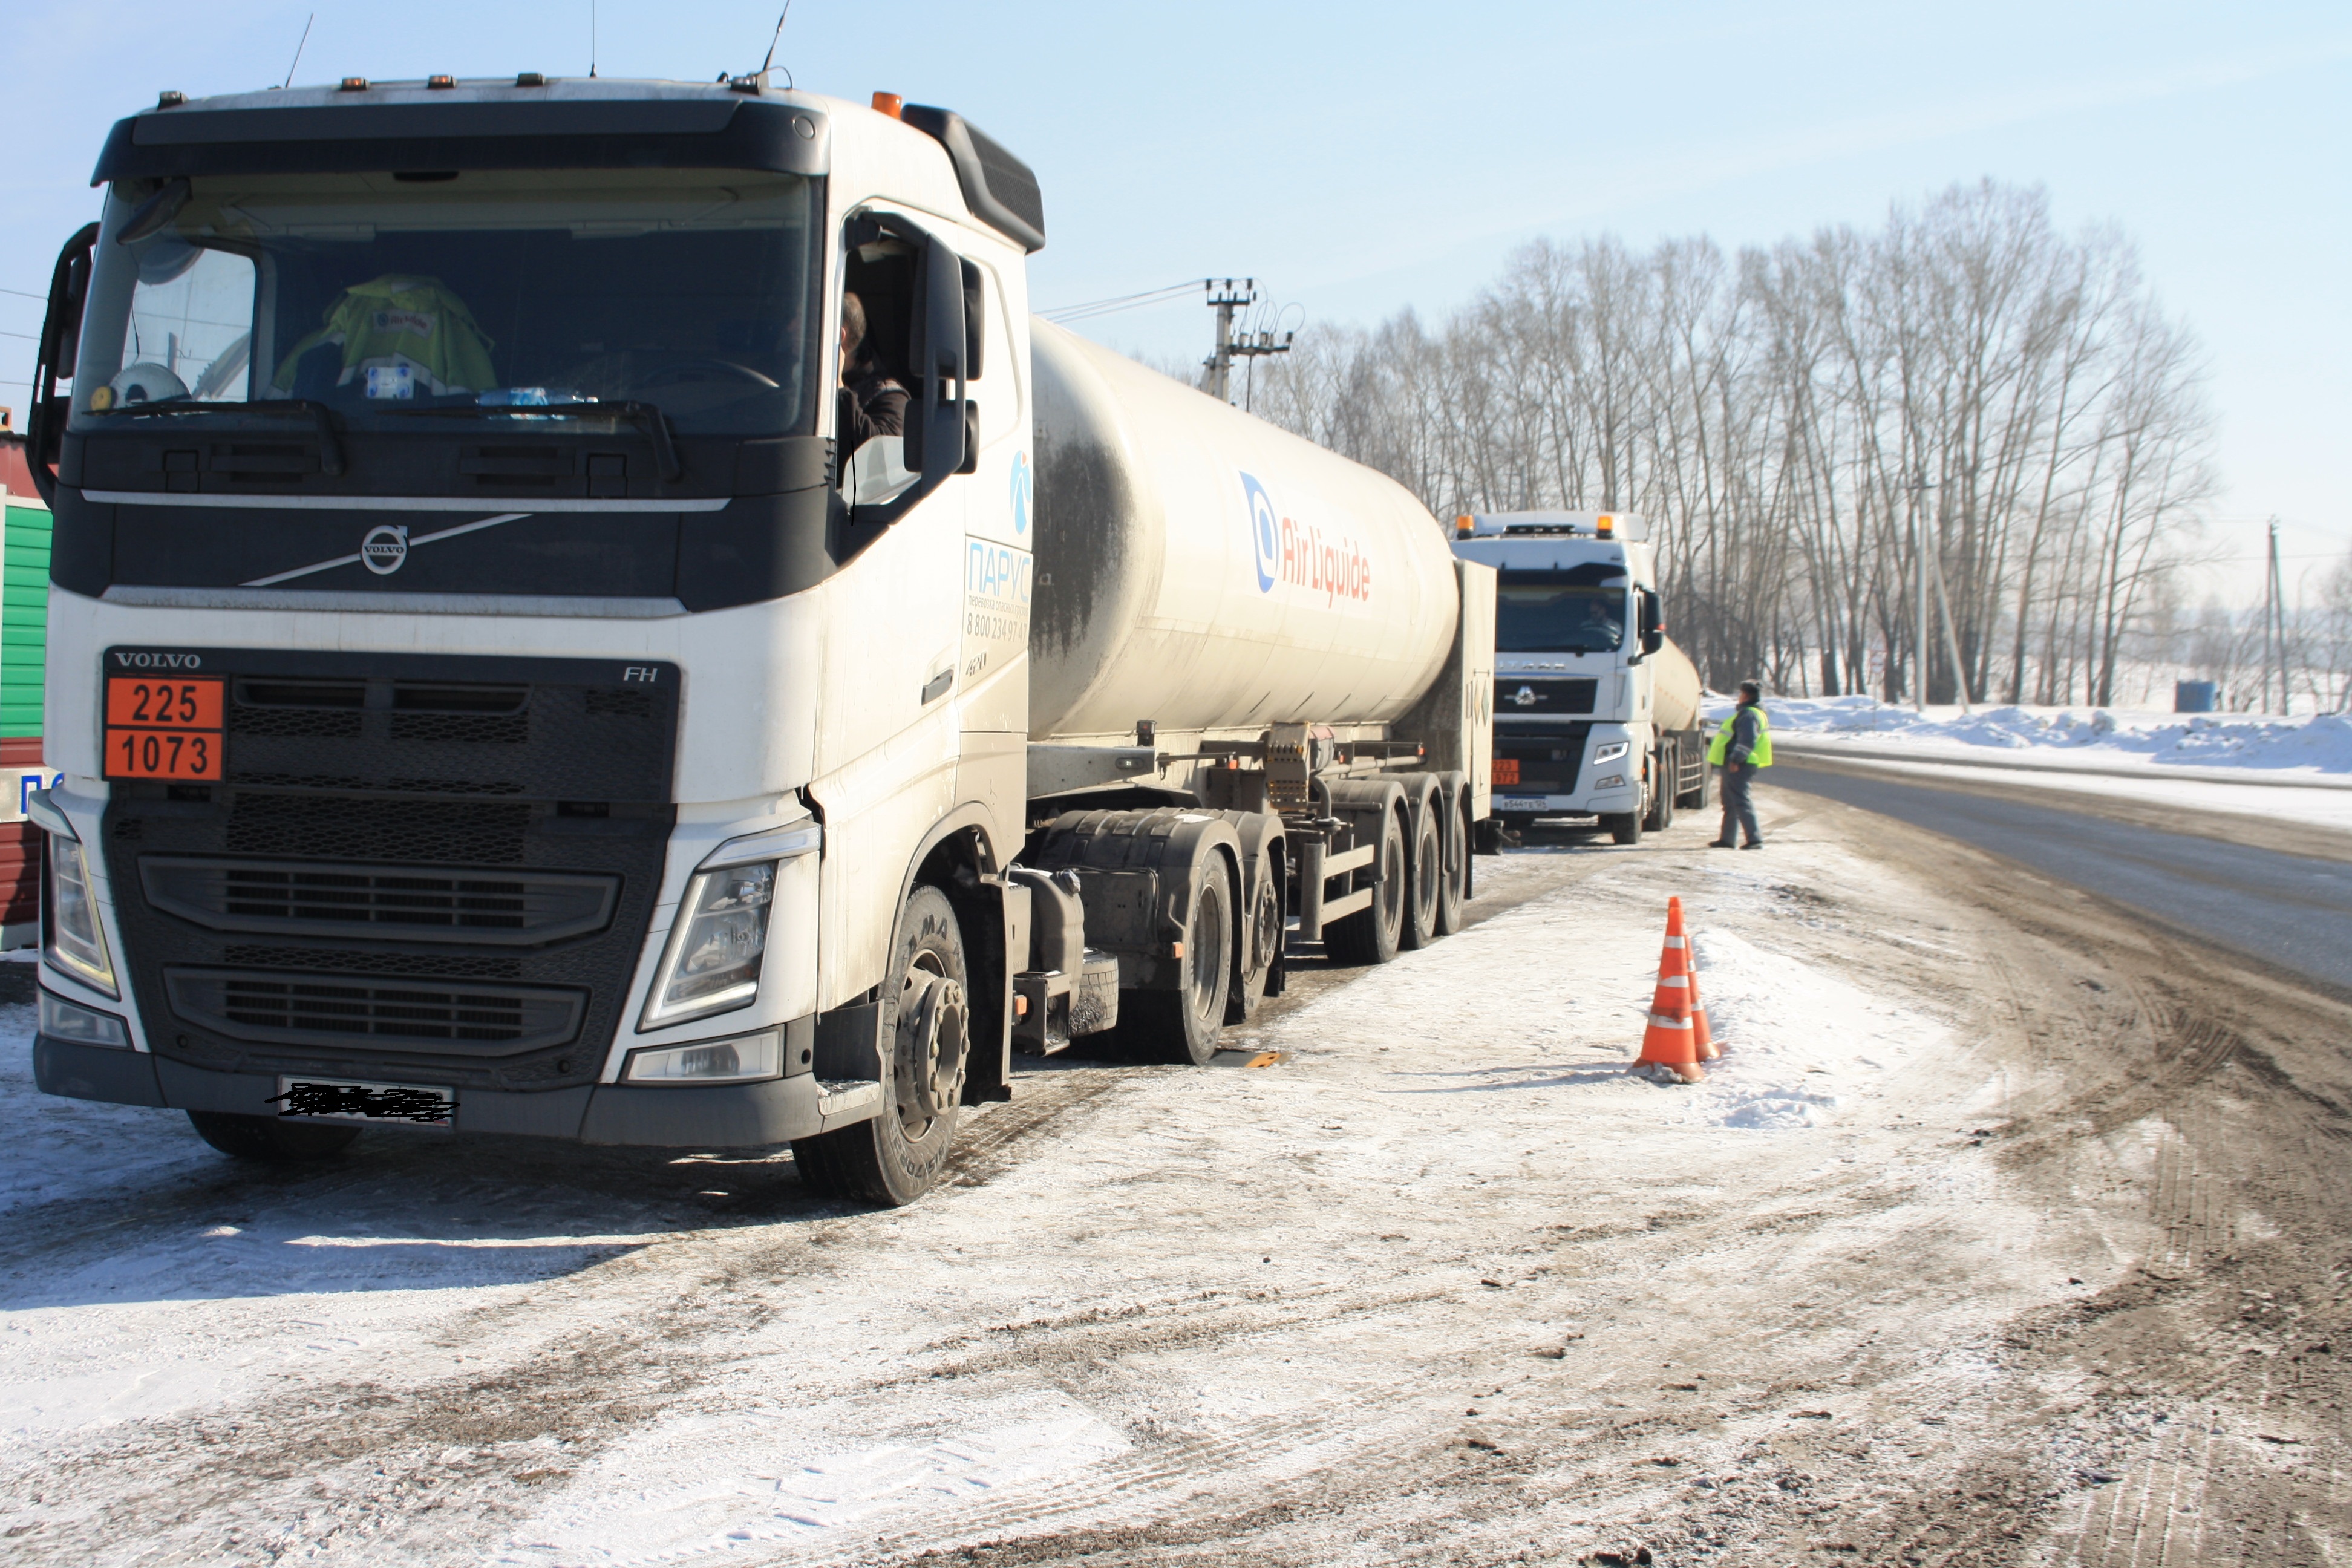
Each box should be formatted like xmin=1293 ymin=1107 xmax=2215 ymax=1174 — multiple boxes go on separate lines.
xmin=139 ymin=856 xmax=621 ymax=945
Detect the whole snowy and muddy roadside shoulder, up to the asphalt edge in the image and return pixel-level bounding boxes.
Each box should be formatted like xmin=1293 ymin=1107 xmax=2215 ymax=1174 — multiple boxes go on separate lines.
xmin=0 ymin=792 xmax=2352 ymax=1568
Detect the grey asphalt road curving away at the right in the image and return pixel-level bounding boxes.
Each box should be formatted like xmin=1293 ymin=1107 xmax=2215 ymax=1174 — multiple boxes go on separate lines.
xmin=1764 ymin=762 xmax=2352 ymax=990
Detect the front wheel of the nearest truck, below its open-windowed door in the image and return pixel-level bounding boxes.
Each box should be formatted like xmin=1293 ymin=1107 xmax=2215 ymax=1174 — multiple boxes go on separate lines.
xmin=792 ymin=886 xmax=972 ymax=1208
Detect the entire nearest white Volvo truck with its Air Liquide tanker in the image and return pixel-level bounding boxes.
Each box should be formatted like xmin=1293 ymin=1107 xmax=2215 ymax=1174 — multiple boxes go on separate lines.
xmin=18 ymin=73 xmax=1494 ymax=1204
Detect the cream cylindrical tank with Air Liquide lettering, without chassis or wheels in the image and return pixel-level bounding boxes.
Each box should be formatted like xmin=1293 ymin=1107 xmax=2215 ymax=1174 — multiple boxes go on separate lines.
xmin=1030 ymin=320 xmax=1460 ymax=740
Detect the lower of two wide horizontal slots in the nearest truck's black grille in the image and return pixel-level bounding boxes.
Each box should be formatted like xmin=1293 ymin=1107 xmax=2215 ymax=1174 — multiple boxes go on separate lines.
xmin=165 ymin=969 xmax=586 ymax=1056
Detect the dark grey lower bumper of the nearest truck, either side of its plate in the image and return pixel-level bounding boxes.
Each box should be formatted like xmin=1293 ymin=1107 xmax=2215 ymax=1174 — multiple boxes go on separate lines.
xmin=33 ymin=1034 xmax=875 ymax=1149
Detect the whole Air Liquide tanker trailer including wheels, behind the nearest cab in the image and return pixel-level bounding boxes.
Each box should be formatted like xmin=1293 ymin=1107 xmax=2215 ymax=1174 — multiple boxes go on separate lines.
xmin=1014 ymin=320 xmax=1494 ymax=1060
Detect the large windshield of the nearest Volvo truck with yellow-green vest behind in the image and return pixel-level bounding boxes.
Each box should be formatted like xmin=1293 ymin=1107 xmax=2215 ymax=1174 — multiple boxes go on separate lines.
xmin=73 ymin=169 xmax=816 ymax=435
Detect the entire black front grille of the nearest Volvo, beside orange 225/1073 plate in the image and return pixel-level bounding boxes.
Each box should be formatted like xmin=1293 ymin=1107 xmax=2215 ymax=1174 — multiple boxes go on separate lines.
xmin=101 ymin=649 xmax=680 ymax=1091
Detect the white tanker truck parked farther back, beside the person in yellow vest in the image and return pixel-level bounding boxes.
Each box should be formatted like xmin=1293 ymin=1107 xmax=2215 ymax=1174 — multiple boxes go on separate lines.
xmin=1454 ymin=512 xmax=1708 ymax=844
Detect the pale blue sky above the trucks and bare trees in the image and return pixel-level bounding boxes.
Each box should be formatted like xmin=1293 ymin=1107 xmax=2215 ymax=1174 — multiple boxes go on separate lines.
xmin=0 ymin=0 xmax=2352 ymax=595
